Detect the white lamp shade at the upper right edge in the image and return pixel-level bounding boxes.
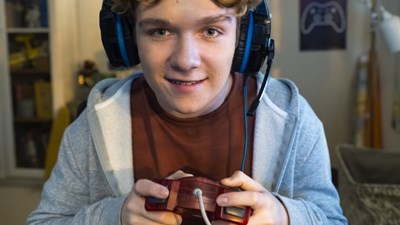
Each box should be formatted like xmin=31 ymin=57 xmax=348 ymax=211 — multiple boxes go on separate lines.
xmin=380 ymin=7 xmax=400 ymax=53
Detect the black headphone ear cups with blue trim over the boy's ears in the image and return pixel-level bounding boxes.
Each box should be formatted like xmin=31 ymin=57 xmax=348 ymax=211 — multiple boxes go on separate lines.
xmin=100 ymin=0 xmax=275 ymax=74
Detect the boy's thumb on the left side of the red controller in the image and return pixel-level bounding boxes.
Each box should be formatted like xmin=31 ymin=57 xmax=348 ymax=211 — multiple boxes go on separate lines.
xmin=133 ymin=179 xmax=169 ymax=198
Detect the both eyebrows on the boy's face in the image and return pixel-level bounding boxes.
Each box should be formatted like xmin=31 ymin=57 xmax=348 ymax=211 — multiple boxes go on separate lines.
xmin=138 ymin=14 xmax=234 ymax=27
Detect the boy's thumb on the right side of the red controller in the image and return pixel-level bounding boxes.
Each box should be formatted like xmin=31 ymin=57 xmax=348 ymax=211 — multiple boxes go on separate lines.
xmin=220 ymin=171 xmax=266 ymax=192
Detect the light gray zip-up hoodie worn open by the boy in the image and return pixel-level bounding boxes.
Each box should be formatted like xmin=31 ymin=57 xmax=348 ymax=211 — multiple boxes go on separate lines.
xmin=28 ymin=72 xmax=347 ymax=225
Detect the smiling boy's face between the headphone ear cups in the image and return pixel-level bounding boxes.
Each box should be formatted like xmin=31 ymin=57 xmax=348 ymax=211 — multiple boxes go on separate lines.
xmin=136 ymin=0 xmax=237 ymax=118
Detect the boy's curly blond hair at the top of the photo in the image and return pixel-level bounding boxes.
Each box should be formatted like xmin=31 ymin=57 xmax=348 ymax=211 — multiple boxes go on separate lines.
xmin=112 ymin=0 xmax=262 ymax=17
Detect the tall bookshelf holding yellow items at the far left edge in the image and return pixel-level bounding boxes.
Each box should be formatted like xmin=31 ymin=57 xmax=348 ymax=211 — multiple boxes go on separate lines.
xmin=2 ymin=0 xmax=53 ymax=176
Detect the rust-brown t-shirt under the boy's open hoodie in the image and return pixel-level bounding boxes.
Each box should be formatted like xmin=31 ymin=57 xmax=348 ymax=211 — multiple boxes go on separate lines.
xmin=131 ymin=74 xmax=256 ymax=181
